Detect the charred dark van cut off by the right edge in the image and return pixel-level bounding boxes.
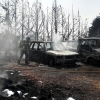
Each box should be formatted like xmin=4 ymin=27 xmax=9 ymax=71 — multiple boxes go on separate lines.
xmin=77 ymin=37 xmax=100 ymax=65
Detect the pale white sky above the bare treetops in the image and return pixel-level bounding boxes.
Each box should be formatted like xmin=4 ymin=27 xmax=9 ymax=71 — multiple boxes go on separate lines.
xmin=29 ymin=0 xmax=100 ymax=26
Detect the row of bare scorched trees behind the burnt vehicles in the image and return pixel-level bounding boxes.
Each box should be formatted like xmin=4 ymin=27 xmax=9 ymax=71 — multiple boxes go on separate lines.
xmin=0 ymin=0 xmax=89 ymax=57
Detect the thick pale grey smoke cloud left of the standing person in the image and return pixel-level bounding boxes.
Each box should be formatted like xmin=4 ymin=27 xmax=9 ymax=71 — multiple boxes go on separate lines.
xmin=0 ymin=32 xmax=20 ymax=60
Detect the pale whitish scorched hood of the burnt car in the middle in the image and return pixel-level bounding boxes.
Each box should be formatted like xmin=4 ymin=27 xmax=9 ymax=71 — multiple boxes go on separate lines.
xmin=46 ymin=50 xmax=78 ymax=56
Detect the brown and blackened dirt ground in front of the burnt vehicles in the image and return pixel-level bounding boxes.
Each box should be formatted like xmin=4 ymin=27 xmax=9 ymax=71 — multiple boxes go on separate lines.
xmin=0 ymin=59 xmax=100 ymax=100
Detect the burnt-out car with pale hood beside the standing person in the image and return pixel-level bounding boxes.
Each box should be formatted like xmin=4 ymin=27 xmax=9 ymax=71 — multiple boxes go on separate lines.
xmin=29 ymin=41 xmax=78 ymax=66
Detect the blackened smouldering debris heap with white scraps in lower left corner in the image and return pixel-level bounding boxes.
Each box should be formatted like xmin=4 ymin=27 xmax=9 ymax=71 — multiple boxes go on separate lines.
xmin=0 ymin=70 xmax=57 ymax=100
